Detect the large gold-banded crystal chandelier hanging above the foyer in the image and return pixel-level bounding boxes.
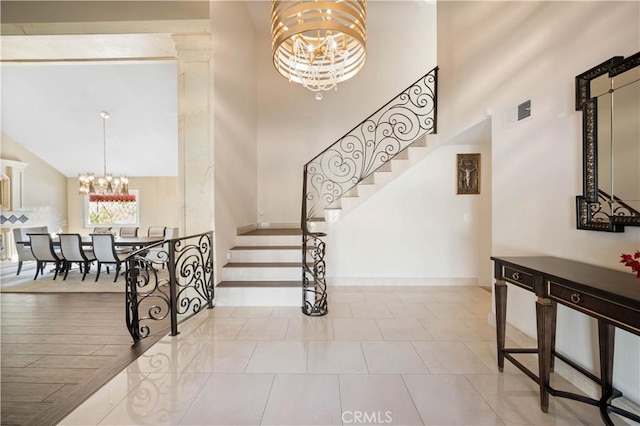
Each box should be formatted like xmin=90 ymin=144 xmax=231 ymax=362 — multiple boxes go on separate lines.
xmin=271 ymin=0 xmax=367 ymax=99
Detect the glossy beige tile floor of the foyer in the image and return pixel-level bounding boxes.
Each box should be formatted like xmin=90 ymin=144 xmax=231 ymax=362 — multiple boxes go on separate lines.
xmin=61 ymin=287 xmax=623 ymax=425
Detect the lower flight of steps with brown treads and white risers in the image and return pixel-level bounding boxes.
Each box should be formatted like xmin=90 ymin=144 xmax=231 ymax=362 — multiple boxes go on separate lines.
xmin=216 ymin=228 xmax=302 ymax=307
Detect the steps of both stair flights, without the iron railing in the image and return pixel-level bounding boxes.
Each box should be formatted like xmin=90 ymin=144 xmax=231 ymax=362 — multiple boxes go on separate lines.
xmin=216 ymin=135 xmax=437 ymax=307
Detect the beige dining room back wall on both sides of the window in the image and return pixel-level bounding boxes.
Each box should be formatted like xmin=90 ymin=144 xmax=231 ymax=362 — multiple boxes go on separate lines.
xmin=66 ymin=177 xmax=179 ymax=235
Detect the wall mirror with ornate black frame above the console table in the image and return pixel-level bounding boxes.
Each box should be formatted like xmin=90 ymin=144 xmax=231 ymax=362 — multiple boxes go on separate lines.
xmin=576 ymin=52 xmax=640 ymax=232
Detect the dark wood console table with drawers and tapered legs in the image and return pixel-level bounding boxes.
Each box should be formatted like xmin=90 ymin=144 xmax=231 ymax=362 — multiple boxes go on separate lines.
xmin=491 ymin=256 xmax=640 ymax=425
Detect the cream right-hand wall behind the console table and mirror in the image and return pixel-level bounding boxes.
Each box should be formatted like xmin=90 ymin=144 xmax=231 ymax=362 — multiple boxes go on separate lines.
xmin=438 ymin=1 xmax=640 ymax=402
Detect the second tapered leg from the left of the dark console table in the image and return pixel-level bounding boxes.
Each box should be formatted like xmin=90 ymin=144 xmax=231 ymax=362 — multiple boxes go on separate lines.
xmin=536 ymin=297 xmax=556 ymax=413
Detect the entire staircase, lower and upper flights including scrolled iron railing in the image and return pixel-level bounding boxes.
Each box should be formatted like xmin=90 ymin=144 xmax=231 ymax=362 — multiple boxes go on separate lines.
xmin=216 ymin=67 xmax=439 ymax=316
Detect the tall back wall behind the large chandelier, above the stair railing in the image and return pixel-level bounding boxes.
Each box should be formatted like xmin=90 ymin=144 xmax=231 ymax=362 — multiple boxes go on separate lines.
xmin=256 ymin=1 xmax=436 ymax=223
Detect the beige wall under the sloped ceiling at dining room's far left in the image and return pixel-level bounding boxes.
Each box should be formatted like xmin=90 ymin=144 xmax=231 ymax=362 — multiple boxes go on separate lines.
xmin=0 ymin=133 xmax=67 ymax=231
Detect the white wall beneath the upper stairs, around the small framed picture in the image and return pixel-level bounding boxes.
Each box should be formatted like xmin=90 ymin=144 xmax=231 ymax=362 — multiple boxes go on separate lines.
xmin=326 ymin=138 xmax=491 ymax=285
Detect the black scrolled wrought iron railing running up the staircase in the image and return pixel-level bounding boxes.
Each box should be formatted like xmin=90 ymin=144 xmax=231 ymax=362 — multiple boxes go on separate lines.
xmin=301 ymin=67 xmax=438 ymax=316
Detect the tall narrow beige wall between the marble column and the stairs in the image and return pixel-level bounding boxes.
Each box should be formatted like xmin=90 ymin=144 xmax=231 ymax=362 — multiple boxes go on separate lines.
xmin=211 ymin=1 xmax=258 ymax=277
